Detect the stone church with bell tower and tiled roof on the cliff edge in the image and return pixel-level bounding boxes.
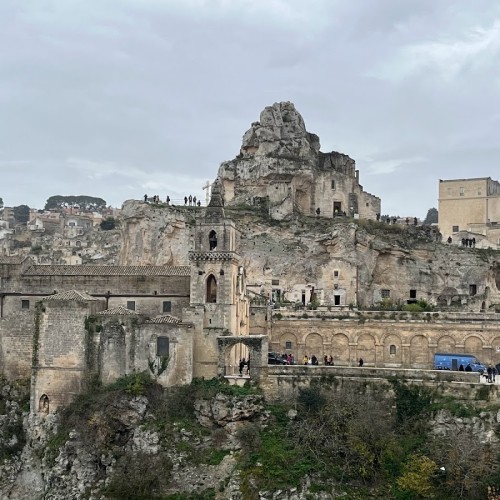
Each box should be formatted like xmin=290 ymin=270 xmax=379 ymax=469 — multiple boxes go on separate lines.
xmin=0 ymin=183 xmax=249 ymax=412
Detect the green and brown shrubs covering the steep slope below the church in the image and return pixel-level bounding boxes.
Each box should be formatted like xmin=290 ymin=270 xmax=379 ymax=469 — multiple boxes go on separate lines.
xmin=34 ymin=374 xmax=500 ymax=500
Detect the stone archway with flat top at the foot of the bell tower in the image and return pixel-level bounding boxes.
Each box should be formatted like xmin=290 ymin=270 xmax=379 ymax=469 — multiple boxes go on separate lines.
xmin=217 ymin=335 xmax=269 ymax=380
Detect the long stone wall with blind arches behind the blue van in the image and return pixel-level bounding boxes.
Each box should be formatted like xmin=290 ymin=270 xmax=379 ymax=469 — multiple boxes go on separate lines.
xmin=269 ymin=312 xmax=500 ymax=369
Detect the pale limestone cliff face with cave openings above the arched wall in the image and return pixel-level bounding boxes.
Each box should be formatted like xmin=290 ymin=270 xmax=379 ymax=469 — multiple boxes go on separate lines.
xmin=230 ymin=213 xmax=500 ymax=311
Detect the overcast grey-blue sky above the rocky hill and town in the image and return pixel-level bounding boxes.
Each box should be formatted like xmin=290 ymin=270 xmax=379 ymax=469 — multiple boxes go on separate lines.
xmin=0 ymin=0 xmax=500 ymax=217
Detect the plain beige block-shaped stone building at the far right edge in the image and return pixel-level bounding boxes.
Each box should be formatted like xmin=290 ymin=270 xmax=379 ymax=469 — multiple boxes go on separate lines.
xmin=439 ymin=177 xmax=500 ymax=248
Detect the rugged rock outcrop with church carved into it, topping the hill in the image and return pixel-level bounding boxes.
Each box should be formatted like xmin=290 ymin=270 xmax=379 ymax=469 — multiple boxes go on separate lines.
xmin=218 ymin=102 xmax=380 ymax=220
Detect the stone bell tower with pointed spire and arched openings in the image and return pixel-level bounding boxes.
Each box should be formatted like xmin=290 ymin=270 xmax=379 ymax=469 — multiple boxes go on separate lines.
xmin=189 ymin=179 xmax=249 ymax=377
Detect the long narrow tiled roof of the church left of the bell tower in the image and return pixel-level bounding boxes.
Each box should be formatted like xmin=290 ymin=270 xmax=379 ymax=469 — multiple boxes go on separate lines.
xmin=24 ymin=265 xmax=191 ymax=276
